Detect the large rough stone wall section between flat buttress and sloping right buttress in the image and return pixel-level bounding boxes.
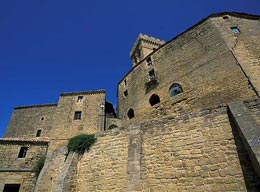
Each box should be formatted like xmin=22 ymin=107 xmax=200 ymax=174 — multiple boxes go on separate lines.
xmin=142 ymin=107 xmax=258 ymax=192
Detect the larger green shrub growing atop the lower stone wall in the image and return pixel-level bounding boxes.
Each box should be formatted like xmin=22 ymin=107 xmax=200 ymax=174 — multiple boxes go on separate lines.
xmin=67 ymin=134 xmax=97 ymax=154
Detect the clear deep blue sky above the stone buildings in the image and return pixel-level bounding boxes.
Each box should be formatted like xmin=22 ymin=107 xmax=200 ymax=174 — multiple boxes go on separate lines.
xmin=0 ymin=0 xmax=260 ymax=137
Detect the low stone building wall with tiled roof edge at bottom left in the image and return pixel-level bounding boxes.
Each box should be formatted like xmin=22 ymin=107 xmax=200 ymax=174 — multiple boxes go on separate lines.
xmin=0 ymin=139 xmax=48 ymax=192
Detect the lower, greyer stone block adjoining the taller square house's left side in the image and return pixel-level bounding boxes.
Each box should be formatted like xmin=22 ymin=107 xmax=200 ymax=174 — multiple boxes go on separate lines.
xmin=5 ymin=104 xmax=57 ymax=138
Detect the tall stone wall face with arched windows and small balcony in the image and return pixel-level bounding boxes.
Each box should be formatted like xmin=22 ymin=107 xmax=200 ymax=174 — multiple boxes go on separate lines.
xmin=118 ymin=17 xmax=260 ymax=126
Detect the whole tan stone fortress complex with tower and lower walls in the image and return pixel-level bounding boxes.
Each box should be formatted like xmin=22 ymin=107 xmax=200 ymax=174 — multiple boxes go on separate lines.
xmin=0 ymin=12 xmax=260 ymax=192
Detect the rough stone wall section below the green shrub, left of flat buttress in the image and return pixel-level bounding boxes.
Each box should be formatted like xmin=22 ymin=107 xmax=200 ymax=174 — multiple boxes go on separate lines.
xmin=76 ymin=131 xmax=128 ymax=192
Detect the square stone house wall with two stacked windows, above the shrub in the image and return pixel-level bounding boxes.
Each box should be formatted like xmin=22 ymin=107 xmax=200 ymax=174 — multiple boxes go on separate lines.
xmin=51 ymin=90 xmax=105 ymax=140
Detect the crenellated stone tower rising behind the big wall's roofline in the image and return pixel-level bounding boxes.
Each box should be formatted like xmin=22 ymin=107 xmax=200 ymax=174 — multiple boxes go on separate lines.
xmin=130 ymin=33 xmax=165 ymax=67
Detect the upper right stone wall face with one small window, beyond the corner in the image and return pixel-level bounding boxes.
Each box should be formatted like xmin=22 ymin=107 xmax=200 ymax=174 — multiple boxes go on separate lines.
xmin=211 ymin=16 xmax=260 ymax=95
